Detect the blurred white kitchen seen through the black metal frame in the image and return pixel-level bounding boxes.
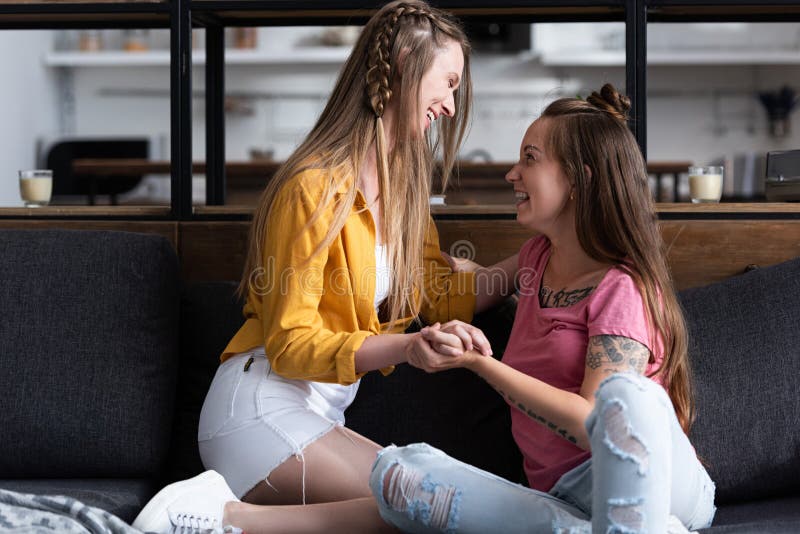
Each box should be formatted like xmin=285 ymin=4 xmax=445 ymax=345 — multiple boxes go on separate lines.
xmin=0 ymin=23 xmax=800 ymax=205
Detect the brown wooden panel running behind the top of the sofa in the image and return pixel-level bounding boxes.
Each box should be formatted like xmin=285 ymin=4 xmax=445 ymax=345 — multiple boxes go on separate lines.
xmin=7 ymin=219 xmax=800 ymax=289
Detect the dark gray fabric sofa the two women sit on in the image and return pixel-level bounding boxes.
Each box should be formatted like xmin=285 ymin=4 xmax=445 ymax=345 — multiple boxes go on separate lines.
xmin=0 ymin=230 xmax=800 ymax=533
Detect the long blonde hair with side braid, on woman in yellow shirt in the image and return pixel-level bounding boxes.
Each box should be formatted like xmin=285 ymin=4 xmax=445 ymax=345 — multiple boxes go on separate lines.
xmin=239 ymin=0 xmax=472 ymax=328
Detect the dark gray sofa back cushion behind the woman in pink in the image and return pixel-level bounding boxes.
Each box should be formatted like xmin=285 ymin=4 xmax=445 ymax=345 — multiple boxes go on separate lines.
xmin=680 ymin=259 xmax=800 ymax=504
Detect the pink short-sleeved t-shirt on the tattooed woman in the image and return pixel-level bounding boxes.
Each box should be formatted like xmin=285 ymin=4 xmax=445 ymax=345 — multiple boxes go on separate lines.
xmin=503 ymin=236 xmax=663 ymax=491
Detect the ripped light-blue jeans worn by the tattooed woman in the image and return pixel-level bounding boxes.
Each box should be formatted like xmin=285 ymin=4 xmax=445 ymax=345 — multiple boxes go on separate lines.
xmin=370 ymin=373 xmax=716 ymax=534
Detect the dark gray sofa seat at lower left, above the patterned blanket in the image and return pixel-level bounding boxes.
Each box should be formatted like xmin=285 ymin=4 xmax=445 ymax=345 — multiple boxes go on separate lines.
xmin=0 ymin=478 xmax=159 ymax=526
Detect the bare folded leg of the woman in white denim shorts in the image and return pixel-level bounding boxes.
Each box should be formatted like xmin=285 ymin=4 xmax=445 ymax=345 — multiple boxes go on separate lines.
xmin=225 ymin=427 xmax=397 ymax=534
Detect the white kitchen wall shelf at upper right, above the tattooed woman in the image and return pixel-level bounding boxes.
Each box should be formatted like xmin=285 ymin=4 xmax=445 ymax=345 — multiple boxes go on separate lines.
xmin=539 ymin=50 xmax=800 ymax=67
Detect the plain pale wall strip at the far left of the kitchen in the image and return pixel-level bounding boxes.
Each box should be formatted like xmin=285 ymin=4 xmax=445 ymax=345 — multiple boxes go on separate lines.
xmin=0 ymin=31 xmax=58 ymax=206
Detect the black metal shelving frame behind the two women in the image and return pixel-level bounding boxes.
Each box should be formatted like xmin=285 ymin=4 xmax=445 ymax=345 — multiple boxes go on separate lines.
xmin=0 ymin=0 xmax=800 ymax=220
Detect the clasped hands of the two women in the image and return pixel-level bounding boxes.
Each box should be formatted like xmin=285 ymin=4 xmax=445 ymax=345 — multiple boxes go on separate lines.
xmin=406 ymin=320 xmax=492 ymax=373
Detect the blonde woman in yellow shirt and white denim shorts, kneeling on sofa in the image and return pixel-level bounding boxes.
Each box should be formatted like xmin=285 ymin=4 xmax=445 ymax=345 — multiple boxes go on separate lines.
xmin=134 ymin=0 xmax=516 ymax=534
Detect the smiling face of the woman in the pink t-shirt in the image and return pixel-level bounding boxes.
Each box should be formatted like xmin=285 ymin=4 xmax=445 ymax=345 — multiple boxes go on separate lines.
xmin=506 ymin=119 xmax=575 ymax=235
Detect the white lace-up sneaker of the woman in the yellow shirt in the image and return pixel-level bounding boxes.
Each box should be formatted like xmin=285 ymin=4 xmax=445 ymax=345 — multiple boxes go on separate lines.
xmin=133 ymin=471 xmax=239 ymax=534
